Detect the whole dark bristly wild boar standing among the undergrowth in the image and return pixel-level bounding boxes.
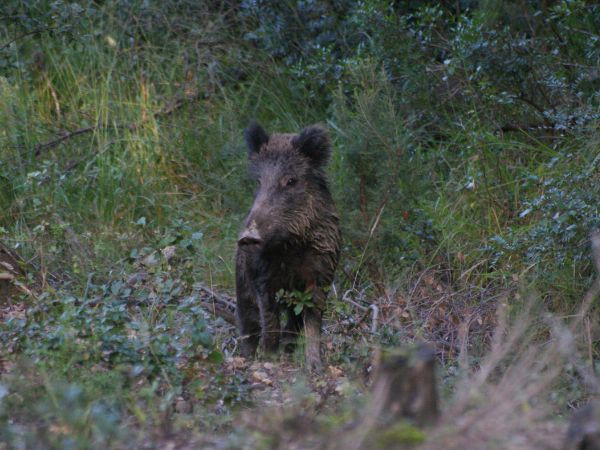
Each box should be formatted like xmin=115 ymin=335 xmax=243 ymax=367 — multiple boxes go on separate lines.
xmin=236 ymin=122 xmax=340 ymax=369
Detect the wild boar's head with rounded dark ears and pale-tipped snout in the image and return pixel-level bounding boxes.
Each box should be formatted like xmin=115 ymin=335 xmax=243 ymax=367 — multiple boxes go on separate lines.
xmin=238 ymin=122 xmax=333 ymax=251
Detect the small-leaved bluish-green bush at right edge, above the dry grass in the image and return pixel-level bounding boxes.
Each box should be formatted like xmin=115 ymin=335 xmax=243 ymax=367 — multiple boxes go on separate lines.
xmin=492 ymin=141 xmax=600 ymax=298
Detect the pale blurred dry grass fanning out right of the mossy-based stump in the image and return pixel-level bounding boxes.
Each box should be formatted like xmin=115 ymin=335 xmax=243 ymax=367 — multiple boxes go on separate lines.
xmin=423 ymin=234 xmax=600 ymax=449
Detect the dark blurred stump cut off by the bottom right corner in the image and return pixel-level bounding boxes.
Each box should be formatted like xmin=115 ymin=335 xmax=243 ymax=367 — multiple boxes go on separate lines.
xmin=564 ymin=401 xmax=600 ymax=450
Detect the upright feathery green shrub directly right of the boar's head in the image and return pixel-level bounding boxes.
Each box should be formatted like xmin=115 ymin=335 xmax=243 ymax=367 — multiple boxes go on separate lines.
xmin=331 ymin=64 xmax=432 ymax=276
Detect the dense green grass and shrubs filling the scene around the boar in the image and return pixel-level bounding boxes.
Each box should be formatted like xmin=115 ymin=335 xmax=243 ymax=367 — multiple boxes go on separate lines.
xmin=0 ymin=0 xmax=600 ymax=448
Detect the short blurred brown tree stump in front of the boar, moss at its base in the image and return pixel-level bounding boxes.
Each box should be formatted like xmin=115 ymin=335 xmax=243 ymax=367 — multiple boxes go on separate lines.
xmin=371 ymin=344 xmax=439 ymax=426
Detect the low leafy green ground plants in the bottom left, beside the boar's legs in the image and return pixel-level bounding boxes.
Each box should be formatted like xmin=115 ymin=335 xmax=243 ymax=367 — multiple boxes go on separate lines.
xmin=0 ymin=278 xmax=245 ymax=448
